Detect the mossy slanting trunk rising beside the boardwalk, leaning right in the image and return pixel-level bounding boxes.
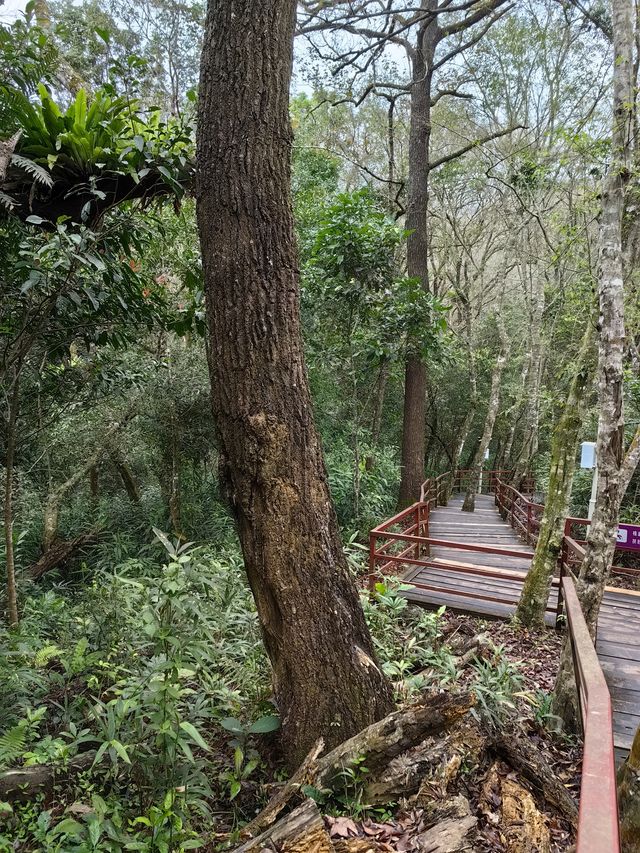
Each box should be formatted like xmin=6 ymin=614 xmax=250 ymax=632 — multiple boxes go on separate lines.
xmin=516 ymin=322 xmax=594 ymax=628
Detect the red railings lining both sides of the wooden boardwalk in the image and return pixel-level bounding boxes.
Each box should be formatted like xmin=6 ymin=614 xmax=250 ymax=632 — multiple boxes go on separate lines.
xmin=369 ymin=471 xmax=624 ymax=853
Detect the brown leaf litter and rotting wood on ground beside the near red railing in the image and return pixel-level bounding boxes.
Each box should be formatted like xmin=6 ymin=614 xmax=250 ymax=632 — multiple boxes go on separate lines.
xmin=218 ymin=612 xmax=581 ymax=853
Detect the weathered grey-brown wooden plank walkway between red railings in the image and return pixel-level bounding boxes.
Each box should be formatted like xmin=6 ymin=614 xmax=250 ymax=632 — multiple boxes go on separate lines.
xmin=403 ymin=495 xmax=640 ymax=759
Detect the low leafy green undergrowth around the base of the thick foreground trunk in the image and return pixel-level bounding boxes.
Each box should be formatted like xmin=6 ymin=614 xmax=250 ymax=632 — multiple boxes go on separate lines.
xmin=0 ymin=532 xmax=528 ymax=853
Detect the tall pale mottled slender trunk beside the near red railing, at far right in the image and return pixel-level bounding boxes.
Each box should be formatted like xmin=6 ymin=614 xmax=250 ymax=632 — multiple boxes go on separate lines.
xmin=554 ymin=0 xmax=634 ymax=728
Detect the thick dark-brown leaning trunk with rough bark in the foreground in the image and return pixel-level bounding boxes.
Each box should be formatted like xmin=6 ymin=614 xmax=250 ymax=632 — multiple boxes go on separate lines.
xmin=197 ymin=0 xmax=392 ymax=766
